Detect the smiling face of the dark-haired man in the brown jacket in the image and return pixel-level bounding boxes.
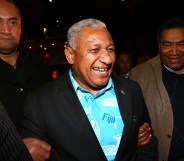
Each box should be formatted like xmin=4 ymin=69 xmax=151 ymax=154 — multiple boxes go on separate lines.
xmin=159 ymin=28 xmax=184 ymax=74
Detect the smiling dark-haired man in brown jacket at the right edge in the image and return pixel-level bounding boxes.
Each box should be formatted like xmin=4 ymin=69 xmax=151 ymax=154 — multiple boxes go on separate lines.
xmin=130 ymin=18 xmax=184 ymax=161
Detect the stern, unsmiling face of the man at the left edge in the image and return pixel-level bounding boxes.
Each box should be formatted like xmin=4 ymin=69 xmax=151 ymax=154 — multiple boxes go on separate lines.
xmin=0 ymin=1 xmax=21 ymax=55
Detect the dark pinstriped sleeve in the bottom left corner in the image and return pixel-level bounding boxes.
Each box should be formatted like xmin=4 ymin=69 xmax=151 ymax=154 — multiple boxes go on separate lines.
xmin=0 ymin=103 xmax=32 ymax=161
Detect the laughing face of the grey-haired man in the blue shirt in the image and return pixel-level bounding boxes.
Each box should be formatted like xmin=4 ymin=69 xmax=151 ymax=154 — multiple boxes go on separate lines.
xmin=66 ymin=27 xmax=116 ymax=94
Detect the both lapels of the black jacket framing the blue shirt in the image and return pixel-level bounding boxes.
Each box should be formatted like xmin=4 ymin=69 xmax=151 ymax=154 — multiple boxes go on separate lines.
xmin=57 ymin=73 xmax=133 ymax=159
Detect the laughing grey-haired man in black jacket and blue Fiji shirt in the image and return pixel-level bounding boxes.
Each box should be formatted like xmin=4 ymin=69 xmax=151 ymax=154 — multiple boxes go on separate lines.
xmin=22 ymin=19 xmax=158 ymax=161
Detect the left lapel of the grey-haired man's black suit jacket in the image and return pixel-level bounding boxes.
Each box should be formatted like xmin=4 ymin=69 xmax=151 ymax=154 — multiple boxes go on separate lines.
xmin=57 ymin=73 xmax=105 ymax=158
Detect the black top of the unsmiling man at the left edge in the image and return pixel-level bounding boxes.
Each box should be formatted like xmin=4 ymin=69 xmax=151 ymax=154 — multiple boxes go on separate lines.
xmin=0 ymin=48 xmax=52 ymax=132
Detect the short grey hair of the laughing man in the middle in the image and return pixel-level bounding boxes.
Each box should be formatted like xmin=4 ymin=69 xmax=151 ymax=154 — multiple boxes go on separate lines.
xmin=67 ymin=18 xmax=106 ymax=50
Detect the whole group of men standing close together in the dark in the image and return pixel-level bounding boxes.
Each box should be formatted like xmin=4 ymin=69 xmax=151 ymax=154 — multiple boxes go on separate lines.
xmin=0 ymin=0 xmax=184 ymax=161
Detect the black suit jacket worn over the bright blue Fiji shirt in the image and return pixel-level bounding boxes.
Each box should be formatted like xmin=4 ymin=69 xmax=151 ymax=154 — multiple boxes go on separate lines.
xmin=22 ymin=73 xmax=158 ymax=161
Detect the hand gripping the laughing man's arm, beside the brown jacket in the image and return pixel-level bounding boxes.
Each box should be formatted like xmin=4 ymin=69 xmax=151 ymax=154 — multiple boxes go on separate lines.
xmin=137 ymin=123 xmax=151 ymax=146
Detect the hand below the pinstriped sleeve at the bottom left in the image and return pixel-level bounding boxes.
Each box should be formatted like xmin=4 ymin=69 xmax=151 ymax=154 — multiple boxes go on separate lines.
xmin=23 ymin=138 xmax=51 ymax=161
